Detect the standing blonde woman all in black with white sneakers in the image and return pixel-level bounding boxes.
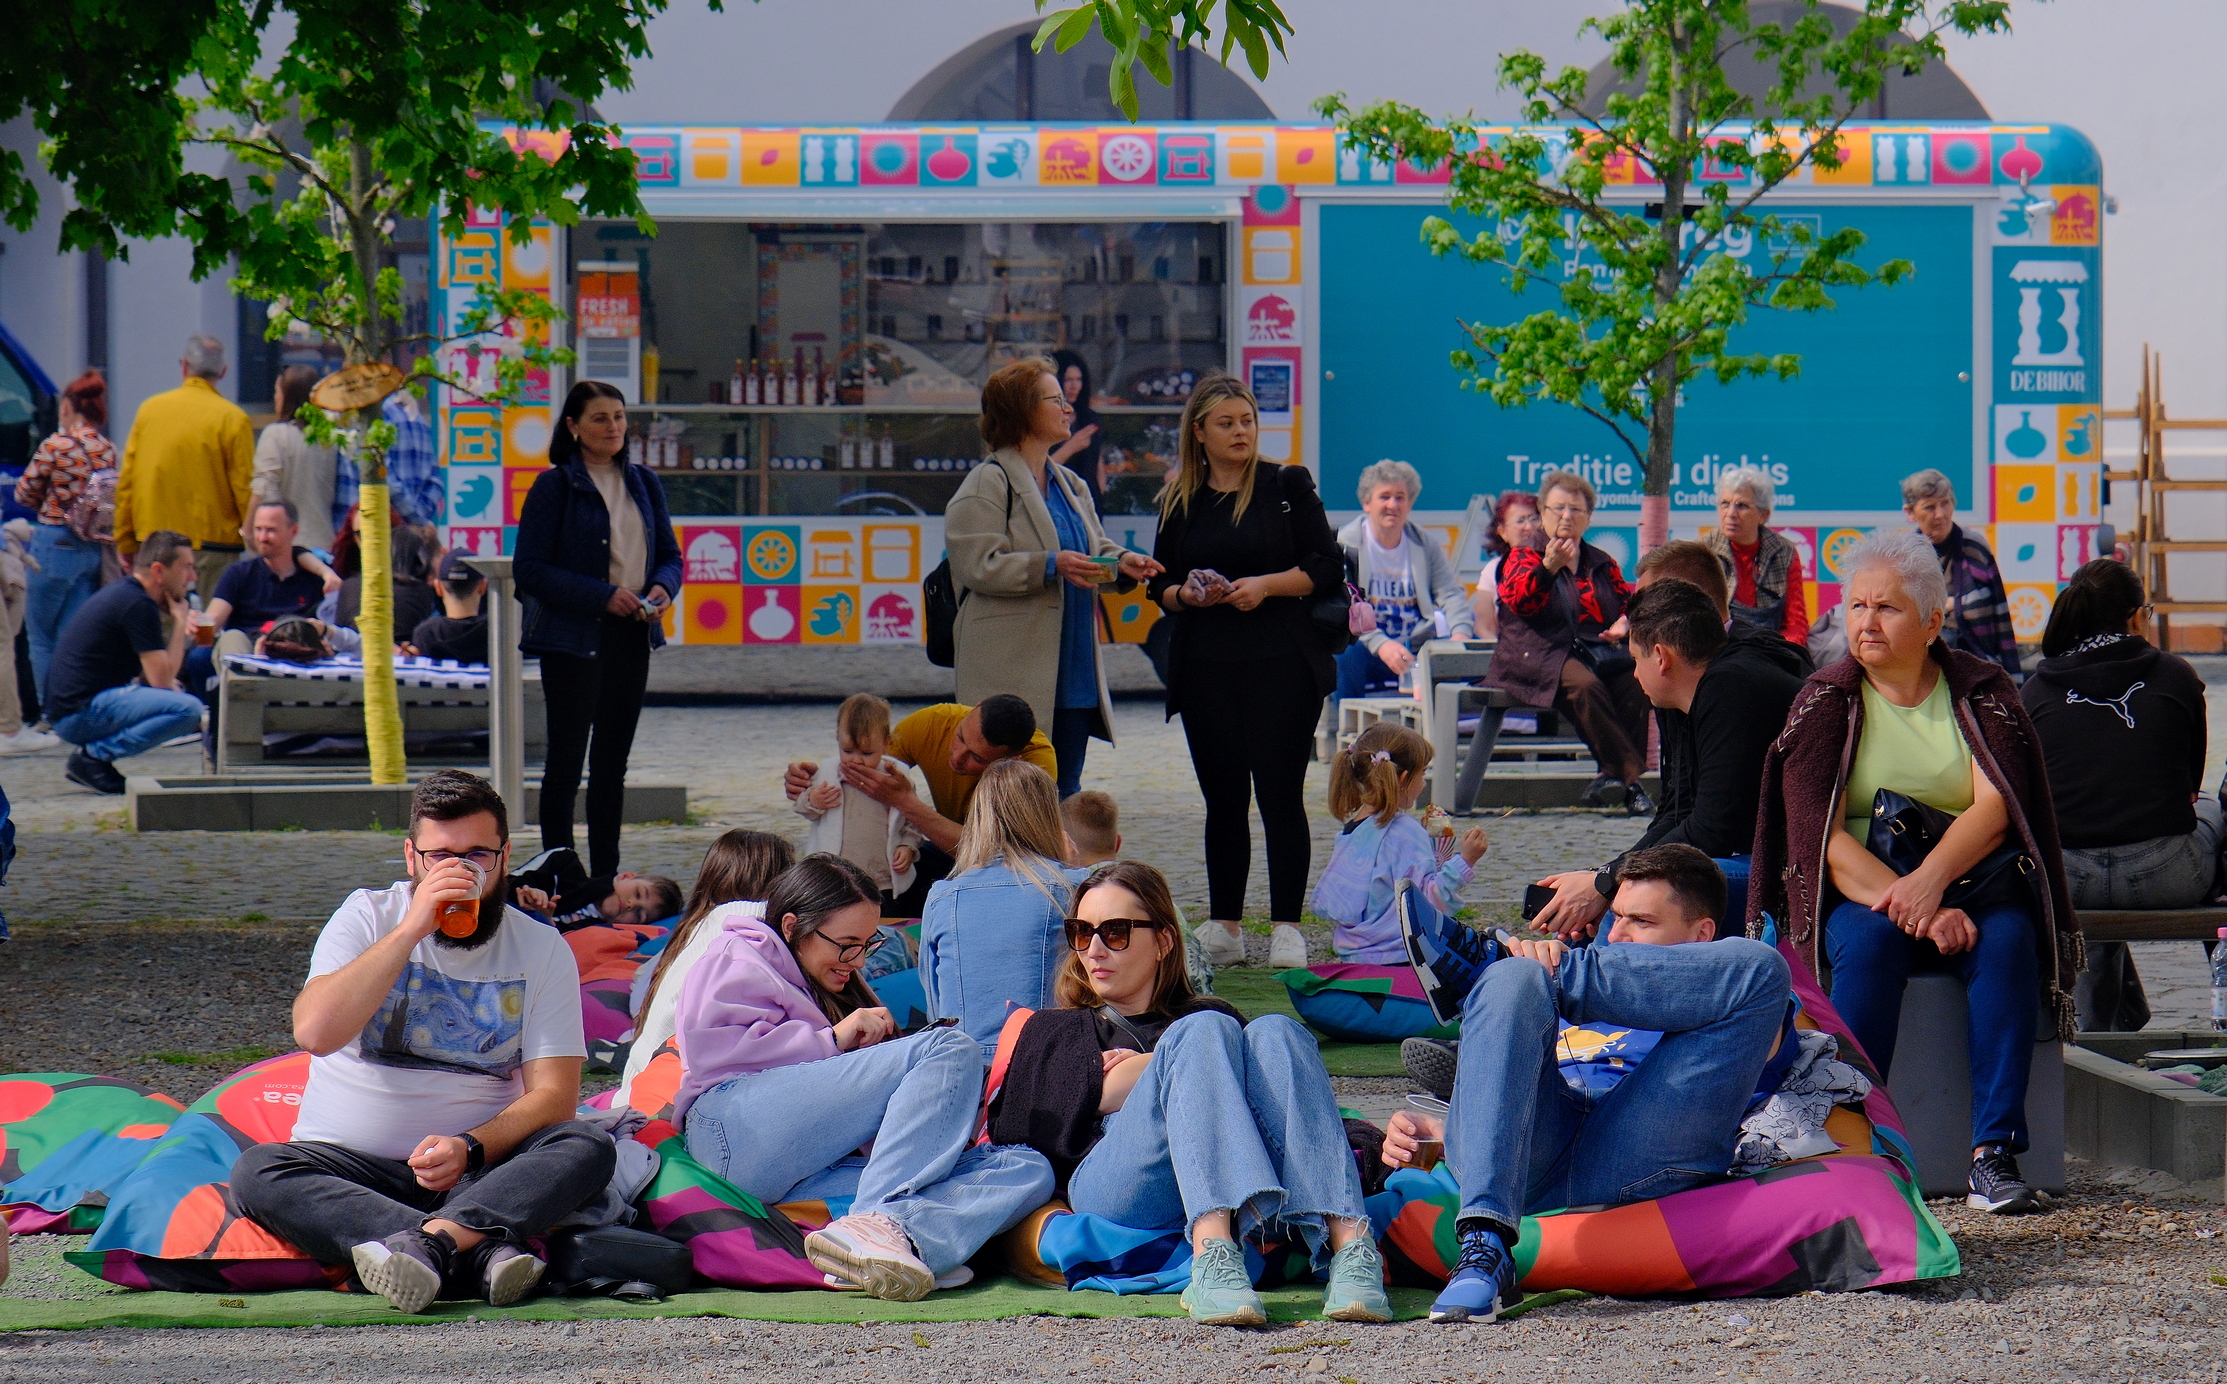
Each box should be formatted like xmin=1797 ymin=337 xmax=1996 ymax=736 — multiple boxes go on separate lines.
xmin=1151 ymin=374 xmax=1345 ymax=965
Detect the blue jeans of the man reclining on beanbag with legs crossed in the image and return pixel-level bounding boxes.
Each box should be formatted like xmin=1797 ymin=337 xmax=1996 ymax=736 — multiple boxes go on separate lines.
xmin=1445 ymin=938 xmax=1793 ymax=1228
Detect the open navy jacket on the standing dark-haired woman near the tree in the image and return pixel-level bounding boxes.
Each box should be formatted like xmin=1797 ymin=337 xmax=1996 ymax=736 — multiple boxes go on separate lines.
xmin=512 ymin=461 xmax=681 ymax=657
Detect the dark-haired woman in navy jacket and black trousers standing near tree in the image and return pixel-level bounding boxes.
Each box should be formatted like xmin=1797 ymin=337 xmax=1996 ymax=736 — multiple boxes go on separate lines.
xmin=512 ymin=379 xmax=681 ymax=876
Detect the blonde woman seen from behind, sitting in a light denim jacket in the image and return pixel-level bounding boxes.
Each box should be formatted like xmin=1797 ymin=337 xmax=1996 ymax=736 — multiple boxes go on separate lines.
xmin=920 ymin=760 xmax=1089 ymax=1052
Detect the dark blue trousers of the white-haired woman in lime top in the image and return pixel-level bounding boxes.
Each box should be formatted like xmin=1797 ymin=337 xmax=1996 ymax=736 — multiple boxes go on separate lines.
xmin=1824 ymin=900 xmax=2042 ymax=1152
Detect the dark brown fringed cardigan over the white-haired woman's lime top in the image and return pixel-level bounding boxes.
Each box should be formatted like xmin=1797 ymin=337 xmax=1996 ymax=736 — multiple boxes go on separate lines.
xmin=1748 ymin=642 xmax=2087 ymax=1036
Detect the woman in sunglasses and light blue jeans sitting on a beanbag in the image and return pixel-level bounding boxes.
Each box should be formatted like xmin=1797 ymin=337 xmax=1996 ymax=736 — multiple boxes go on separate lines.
xmin=989 ymin=860 xmax=1392 ymax=1326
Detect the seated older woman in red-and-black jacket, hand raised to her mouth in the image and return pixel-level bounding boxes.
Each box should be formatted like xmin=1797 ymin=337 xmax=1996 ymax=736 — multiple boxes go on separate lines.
xmin=1485 ymin=470 xmax=1655 ymax=818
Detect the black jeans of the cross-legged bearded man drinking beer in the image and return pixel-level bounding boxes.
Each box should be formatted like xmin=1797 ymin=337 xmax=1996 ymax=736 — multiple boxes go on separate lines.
xmin=232 ymin=1119 xmax=619 ymax=1264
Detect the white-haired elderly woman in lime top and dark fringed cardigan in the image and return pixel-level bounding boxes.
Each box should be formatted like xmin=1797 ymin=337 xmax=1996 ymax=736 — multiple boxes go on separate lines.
xmin=1748 ymin=530 xmax=2082 ymax=1212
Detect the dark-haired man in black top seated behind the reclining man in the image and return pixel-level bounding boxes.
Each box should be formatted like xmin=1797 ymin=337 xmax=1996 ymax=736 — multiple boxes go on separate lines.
xmin=1534 ymin=562 xmax=1804 ymax=936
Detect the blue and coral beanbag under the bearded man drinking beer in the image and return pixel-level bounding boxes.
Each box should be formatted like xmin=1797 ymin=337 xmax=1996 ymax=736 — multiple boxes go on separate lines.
xmin=65 ymin=1052 xmax=347 ymax=1293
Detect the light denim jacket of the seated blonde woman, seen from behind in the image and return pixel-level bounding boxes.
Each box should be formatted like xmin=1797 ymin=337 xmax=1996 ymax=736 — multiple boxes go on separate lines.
xmin=920 ymin=860 xmax=1089 ymax=1054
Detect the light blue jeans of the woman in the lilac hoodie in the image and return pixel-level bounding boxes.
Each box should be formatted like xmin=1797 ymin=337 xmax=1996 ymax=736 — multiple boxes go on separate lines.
xmin=686 ymin=1027 xmax=1053 ymax=1275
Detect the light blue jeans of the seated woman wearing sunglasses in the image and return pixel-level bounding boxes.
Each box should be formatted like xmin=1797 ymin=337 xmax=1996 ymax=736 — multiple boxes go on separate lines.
xmin=1067 ymin=1012 xmax=1365 ymax=1266
